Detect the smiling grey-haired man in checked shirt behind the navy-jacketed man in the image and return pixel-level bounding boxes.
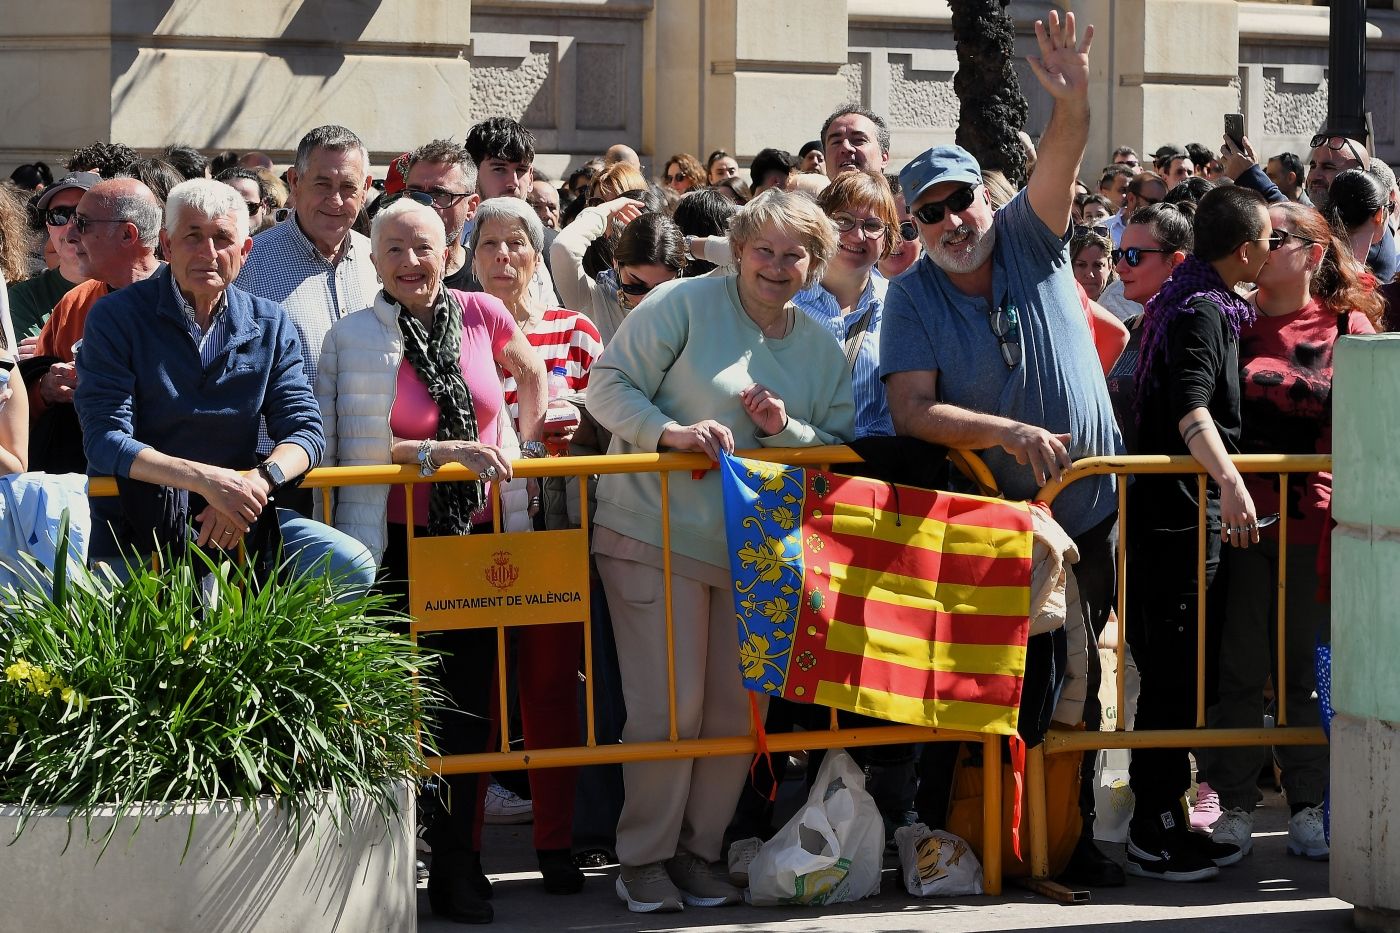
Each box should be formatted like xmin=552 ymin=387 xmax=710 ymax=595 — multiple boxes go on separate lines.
xmin=238 ymin=125 xmax=379 ymax=501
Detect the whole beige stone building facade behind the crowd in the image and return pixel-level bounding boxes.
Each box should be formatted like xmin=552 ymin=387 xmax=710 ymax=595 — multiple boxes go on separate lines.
xmin=0 ymin=0 xmax=1400 ymax=177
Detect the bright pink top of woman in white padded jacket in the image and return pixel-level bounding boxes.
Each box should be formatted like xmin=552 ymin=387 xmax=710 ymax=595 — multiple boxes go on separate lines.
xmin=388 ymin=290 xmax=518 ymax=525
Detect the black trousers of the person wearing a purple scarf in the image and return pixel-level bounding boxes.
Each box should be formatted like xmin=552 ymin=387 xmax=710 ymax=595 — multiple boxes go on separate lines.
xmin=1127 ymin=515 xmax=1224 ymax=817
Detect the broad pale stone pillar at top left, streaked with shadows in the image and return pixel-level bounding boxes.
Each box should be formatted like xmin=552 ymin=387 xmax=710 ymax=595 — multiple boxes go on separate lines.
xmin=0 ymin=0 xmax=470 ymax=164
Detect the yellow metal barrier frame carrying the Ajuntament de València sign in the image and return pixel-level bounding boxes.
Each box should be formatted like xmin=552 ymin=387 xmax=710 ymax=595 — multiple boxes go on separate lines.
xmin=88 ymin=447 xmax=1002 ymax=895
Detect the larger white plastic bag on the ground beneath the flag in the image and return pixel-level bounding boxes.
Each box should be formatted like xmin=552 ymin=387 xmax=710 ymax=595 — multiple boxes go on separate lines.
xmin=749 ymin=748 xmax=885 ymax=906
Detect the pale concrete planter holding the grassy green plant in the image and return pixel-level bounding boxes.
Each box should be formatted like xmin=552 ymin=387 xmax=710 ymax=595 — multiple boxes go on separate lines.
xmin=0 ymin=786 xmax=417 ymax=933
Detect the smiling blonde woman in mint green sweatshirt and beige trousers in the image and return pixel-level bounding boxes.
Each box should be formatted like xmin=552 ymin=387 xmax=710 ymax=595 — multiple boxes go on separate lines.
xmin=588 ymin=191 xmax=855 ymax=912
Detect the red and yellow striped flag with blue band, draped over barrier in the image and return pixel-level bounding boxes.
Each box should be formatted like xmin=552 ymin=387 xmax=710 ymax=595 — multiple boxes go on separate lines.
xmin=721 ymin=457 xmax=1032 ymax=735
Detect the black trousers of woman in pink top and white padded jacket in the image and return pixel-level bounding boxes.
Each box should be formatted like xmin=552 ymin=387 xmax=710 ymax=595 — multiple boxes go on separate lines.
xmin=379 ymin=524 xmax=498 ymax=853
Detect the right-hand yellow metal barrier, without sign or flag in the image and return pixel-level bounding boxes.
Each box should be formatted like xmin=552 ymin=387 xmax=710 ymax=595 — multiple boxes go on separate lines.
xmin=1026 ymin=454 xmax=1331 ymax=878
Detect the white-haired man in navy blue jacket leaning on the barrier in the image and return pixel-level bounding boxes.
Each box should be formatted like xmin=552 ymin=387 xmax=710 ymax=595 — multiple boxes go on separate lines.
xmin=76 ymin=178 xmax=374 ymax=587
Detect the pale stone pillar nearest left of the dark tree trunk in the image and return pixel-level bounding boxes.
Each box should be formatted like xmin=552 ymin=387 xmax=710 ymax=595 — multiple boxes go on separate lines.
xmin=645 ymin=0 xmax=848 ymax=165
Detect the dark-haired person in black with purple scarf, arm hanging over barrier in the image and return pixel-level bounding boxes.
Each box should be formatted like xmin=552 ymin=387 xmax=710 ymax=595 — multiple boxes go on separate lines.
xmin=1126 ymin=186 xmax=1273 ymax=881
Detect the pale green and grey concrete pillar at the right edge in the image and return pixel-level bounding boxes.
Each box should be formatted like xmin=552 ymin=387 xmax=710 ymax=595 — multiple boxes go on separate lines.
xmin=1331 ymin=335 xmax=1400 ymax=932
